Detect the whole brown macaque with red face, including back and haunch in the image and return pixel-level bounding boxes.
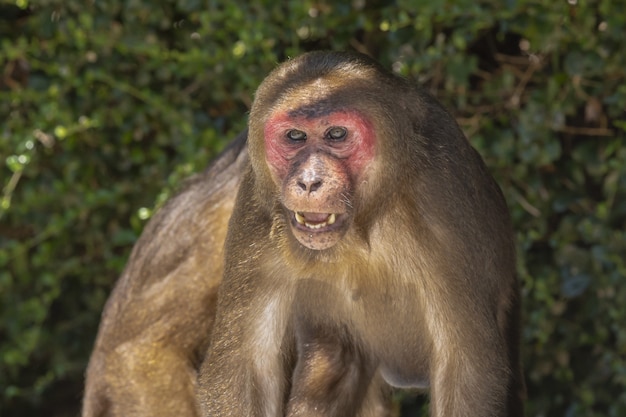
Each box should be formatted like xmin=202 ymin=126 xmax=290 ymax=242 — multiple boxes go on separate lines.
xmin=83 ymin=53 xmax=524 ymax=417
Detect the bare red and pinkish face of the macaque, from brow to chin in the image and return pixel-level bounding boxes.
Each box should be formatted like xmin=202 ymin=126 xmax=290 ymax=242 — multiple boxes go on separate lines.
xmin=264 ymin=111 xmax=375 ymax=250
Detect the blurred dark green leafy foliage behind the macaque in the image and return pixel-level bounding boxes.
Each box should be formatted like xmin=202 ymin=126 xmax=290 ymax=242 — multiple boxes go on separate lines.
xmin=0 ymin=0 xmax=626 ymax=417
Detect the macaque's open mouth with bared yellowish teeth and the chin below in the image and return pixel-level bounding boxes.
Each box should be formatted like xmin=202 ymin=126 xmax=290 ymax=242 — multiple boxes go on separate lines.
xmin=291 ymin=211 xmax=346 ymax=250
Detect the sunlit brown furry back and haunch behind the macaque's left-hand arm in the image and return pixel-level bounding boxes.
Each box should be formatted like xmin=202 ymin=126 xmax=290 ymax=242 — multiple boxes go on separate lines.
xmin=81 ymin=132 xmax=248 ymax=417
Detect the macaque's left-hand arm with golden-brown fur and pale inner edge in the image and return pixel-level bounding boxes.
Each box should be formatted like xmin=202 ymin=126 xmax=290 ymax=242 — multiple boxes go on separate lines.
xmin=198 ymin=172 xmax=290 ymax=417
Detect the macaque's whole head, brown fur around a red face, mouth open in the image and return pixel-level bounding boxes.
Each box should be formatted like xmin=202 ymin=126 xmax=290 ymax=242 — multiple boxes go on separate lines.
xmin=249 ymin=53 xmax=410 ymax=250
